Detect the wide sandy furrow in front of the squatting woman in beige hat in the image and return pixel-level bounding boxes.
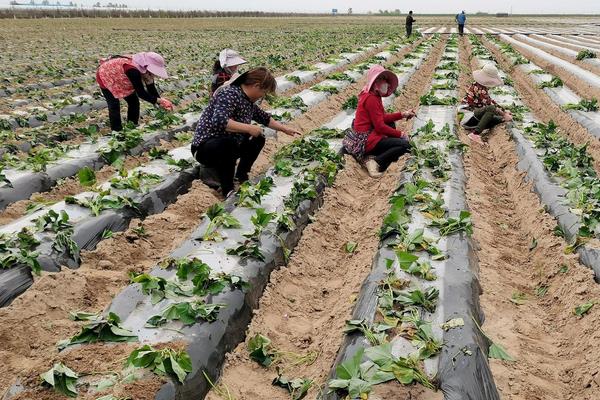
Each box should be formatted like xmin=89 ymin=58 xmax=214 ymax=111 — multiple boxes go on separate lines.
xmin=461 ymin=36 xmax=600 ymax=400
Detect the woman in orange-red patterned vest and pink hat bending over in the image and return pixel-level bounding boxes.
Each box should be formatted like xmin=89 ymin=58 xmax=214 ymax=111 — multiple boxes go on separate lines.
xmin=96 ymin=52 xmax=173 ymax=131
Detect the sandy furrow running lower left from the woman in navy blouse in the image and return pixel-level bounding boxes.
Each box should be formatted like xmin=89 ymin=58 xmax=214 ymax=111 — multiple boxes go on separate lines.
xmin=0 ymin=181 xmax=218 ymax=393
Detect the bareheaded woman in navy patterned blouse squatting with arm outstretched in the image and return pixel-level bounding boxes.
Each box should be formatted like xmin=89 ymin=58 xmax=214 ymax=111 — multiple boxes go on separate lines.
xmin=192 ymin=68 xmax=300 ymax=196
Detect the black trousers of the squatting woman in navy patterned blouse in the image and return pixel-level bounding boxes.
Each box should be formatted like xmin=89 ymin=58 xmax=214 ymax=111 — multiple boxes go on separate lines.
xmin=192 ymin=134 xmax=265 ymax=196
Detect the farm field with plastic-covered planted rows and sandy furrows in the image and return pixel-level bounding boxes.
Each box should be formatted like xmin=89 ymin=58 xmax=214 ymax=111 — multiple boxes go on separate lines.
xmin=0 ymin=17 xmax=600 ymax=400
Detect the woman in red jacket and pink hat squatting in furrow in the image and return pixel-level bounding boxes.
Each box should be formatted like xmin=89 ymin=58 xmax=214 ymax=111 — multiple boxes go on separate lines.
xmin=344 ymin=65 xmax=415 ymax=178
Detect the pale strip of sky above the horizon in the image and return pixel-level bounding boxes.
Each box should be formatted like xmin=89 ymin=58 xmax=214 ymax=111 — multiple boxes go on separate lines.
xmin=0 ymin=0 xmax=600 ymax=14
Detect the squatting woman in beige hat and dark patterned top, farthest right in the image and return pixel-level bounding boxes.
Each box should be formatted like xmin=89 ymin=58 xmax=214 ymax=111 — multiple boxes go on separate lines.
xmin=461 ymin=64 xmax=512 ymax=144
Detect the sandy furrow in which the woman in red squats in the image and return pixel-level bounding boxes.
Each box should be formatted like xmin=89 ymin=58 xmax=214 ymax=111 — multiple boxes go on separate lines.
xmin=207 ymin=37 xmax=444 ymax=400
